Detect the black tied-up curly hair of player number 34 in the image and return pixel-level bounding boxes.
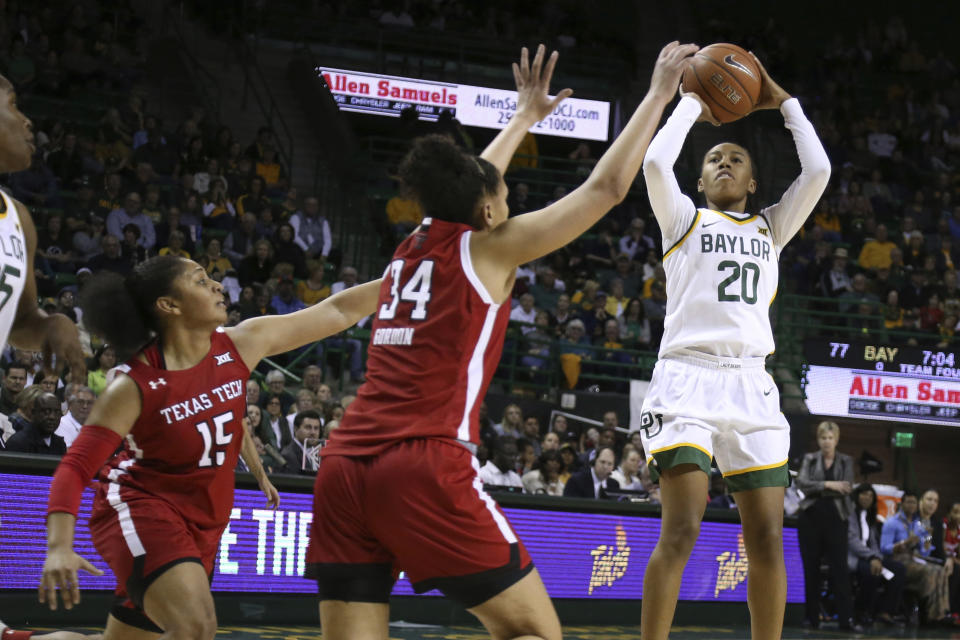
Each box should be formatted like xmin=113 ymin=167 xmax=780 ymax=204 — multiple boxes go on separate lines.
xmin=400 ymin=134 xmax=500 ymax=228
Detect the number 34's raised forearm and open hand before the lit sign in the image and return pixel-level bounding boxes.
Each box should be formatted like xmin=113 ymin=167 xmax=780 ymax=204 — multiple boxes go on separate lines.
xmin=480 ymin=44 xmax=573 ymax=175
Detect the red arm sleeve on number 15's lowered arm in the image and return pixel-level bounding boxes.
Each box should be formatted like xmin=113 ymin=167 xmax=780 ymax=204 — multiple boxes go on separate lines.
xmin=47 ymin=425 xmax=123 ymax=516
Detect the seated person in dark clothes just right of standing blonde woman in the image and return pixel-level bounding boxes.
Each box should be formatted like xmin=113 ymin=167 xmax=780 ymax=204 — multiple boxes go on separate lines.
xmin=847 ymin=483 xmax=906 ymax=626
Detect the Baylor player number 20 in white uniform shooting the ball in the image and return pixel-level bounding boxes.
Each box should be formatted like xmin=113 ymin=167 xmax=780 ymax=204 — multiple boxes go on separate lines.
xmin=641 ymin=55 xmax=830 ymax=640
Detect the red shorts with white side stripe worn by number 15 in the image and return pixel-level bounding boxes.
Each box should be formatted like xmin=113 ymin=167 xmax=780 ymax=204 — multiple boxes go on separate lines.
xmin=90 ymin=482 xmax=224 ymax=633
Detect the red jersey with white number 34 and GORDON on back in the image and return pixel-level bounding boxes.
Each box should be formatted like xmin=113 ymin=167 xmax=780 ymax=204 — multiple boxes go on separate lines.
xmin=323 ymin=218 xmax=510 ymax=456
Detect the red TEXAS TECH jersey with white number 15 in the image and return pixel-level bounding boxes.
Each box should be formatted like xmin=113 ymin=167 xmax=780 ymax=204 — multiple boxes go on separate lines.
xmin=100 ymin=329 xmax=250 ymax=528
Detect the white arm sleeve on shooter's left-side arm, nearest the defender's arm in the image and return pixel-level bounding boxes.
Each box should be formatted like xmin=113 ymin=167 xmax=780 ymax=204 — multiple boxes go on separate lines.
xmin=643 ymin=98 xmax=700 ymax=245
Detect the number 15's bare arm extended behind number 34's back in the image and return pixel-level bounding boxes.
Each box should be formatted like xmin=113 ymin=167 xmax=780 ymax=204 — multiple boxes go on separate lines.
xmin=227 ymin=278 xmax=382 ymax=369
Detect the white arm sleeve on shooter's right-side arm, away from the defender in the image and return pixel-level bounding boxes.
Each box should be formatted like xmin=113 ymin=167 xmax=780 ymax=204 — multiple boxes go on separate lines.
xmin=763 ymin=98 xmax=830 ymax=247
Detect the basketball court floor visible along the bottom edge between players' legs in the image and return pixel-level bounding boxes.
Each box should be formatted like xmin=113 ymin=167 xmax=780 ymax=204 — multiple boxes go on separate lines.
xmin=36 ymin=623 xmax=960 ymax=640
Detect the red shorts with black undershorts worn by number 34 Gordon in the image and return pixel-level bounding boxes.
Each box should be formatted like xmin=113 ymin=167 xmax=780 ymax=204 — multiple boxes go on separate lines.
xmin=307 ymin=439 xmax=533 ymax=608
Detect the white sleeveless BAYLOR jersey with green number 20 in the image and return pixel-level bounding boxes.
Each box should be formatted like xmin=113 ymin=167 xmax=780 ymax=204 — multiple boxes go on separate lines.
xmin=660 ymin=209 xmax=780 ymax=358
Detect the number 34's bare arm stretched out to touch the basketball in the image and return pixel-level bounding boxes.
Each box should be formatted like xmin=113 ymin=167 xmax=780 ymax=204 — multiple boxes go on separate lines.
xmin=472 ymin=42 xmax=698 ymax=269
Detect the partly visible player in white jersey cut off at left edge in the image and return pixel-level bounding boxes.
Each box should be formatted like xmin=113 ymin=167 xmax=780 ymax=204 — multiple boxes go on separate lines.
xmin=0 ymin=76 xmax=87 ymax=380
